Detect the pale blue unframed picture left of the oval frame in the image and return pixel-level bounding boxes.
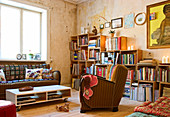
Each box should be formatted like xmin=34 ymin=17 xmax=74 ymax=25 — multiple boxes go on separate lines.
xmin=124 ymin=13 xmax=134 ymax=28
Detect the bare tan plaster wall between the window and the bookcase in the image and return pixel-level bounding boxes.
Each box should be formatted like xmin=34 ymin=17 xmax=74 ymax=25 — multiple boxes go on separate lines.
xmin=20 ymin=0 xmax=77 ymax=84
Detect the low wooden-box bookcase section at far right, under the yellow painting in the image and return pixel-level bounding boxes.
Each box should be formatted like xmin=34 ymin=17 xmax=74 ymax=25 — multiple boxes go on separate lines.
xmin=131 ymin=63 xmax=170 ymax=101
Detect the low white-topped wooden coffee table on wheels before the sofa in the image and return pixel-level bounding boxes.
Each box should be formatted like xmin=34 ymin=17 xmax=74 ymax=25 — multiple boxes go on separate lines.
xmin=6 ymin=85 xmax=71 ymax=111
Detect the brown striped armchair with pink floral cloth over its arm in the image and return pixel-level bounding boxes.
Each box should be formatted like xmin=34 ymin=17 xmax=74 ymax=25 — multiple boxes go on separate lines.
xmin=80 ymin=65 xmax=128 ymax=113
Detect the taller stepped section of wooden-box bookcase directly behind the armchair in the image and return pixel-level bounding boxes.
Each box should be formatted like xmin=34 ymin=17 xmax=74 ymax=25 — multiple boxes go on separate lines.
xmin=70 ymin=34 xmax=142 ymax=90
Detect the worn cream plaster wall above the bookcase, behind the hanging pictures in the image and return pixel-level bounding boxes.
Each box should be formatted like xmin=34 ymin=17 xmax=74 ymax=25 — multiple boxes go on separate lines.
xmin=77 ymin=0 xmax=170 ymax=61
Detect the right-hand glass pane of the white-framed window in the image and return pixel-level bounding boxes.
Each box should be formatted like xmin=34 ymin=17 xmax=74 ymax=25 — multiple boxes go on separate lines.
xmin=23 ymin=11 xmax=41 ymax=53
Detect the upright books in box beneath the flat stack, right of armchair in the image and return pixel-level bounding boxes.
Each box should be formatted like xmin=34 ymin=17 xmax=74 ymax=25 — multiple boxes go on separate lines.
xmin=137 ymin=67 xmax=156 ymax=81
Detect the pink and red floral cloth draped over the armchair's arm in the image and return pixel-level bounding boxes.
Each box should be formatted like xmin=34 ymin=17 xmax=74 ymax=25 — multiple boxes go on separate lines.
xmin=82 ymin=75 xmax=98 ymax=100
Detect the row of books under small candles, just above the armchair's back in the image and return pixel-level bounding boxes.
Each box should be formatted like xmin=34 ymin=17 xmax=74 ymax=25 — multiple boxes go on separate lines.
xmin=121 ymin=54 xmax=137 ymax=64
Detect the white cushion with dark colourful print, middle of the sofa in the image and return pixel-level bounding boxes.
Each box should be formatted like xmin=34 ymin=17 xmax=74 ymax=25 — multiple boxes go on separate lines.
xmin=25 ymin=68 xmax=43 ymax=79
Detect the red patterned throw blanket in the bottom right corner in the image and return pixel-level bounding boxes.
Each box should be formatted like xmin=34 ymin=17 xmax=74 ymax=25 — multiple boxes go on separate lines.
xmin=134 ymin=97 xmax=170 ymax=117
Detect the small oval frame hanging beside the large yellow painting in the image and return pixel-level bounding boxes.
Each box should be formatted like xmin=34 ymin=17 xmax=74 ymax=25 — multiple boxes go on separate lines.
xmin=134 ymin=12 xmax=146 ymax=25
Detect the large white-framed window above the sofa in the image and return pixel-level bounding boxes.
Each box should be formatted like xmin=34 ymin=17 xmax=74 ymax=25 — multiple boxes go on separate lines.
xmin=0 ymin=0 xmax=47 ymax=60
